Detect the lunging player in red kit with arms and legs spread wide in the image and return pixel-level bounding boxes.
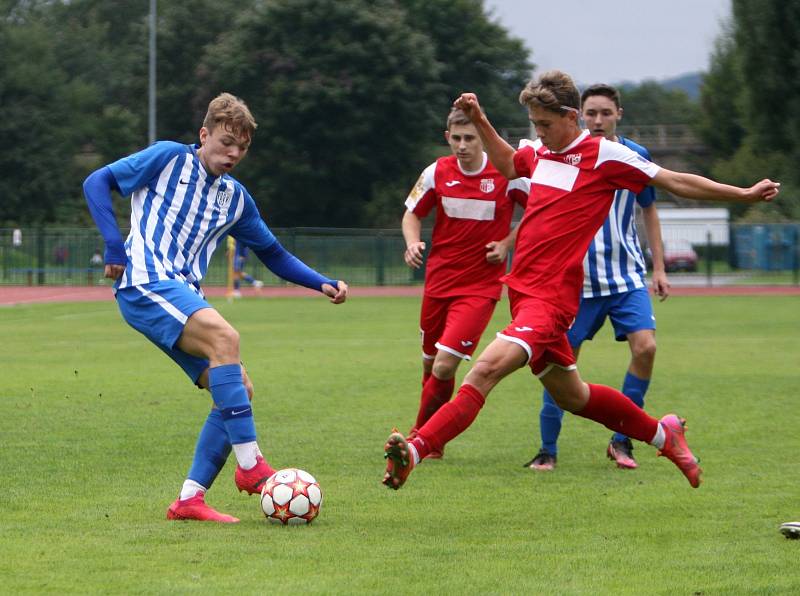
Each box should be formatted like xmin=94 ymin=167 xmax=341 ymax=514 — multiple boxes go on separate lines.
xmin=383 ymin=71 xmax=779 ymax=490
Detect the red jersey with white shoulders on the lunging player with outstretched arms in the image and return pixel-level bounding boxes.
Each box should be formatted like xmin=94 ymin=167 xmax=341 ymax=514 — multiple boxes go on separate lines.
xmin=510 ymin=131 xmax=660 ymax=317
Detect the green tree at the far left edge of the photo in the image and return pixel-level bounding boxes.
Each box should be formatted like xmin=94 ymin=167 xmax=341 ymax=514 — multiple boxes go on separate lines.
xmin=0 ymin=5 xmax=95 ymax=223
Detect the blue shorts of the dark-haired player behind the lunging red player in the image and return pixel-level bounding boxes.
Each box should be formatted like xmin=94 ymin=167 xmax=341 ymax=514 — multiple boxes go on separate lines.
xmin=567 ymin=288 xmax=656 ymax=348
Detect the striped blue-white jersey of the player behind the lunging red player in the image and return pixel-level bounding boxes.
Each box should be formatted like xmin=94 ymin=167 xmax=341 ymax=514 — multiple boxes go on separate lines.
xmin=583 ymin=135 xmax=656 ymax=298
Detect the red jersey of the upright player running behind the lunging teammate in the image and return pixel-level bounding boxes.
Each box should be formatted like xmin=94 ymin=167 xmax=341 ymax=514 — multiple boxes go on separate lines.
xmin=406 ymin=154 xmax=530 ymax=300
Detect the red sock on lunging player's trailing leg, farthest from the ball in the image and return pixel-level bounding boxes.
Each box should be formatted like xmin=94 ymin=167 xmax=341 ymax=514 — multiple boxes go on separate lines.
xmin=574 ymin=384 xmax=658 ymax=443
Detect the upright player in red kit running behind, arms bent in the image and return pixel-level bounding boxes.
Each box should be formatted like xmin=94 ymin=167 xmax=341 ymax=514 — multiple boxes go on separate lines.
xmin=402 ymin=109 xmax=530 ymax=458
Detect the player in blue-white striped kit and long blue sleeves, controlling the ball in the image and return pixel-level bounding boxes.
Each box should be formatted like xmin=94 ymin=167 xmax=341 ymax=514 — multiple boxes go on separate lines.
xmin=83 ymin=93 xmax=347 ymax=522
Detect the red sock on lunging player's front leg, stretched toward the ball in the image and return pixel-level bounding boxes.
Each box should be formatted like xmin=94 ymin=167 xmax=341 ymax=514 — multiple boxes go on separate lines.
xmin=412 ymin=384 xmax=488 ymax=460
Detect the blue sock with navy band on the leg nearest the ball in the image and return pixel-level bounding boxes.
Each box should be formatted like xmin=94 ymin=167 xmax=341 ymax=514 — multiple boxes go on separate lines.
xmin=208 ymin=364 xmax=256 ymax=445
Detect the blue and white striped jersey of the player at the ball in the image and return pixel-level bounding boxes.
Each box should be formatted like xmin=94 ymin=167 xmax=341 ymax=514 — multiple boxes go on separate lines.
xmin=108 ymin=141 xmax=277 ymax=295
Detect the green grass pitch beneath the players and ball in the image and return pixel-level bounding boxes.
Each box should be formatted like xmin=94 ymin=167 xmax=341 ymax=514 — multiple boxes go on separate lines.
xmin=0 ymin=296 xmax=800 ymax=594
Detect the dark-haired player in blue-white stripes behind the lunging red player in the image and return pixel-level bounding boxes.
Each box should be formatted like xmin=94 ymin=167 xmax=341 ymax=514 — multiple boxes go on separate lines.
xmin=525 ymin=84 xmax=669 ymax=470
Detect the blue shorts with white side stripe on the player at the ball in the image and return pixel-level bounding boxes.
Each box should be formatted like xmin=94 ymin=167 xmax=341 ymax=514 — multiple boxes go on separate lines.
xmin=117 ymin=280 xmax=211 ymax=383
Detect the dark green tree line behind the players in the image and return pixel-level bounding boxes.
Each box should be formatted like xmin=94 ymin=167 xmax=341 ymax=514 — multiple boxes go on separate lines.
xmin=0 ymin=0 xmax=800 ymax=227
